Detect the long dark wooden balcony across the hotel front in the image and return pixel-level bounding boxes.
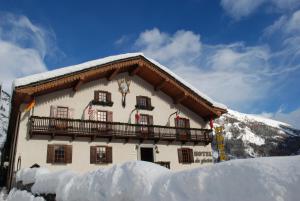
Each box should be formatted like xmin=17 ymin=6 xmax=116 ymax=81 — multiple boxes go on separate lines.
xmin=29 ymin=116 xmax=212 ymax=144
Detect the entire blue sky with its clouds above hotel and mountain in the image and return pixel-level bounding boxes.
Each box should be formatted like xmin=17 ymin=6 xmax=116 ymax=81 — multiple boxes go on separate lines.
xmin=0 ymin=0 xmax=300 ymax=128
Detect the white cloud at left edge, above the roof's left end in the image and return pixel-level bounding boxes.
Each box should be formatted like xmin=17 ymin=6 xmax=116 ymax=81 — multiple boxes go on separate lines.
xmin=0 ymin=13 xmax=56 ymax=91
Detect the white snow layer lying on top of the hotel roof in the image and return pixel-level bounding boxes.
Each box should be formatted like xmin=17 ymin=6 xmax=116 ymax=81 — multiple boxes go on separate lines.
xmin=13 ymin=52 xmax=227 ymax=110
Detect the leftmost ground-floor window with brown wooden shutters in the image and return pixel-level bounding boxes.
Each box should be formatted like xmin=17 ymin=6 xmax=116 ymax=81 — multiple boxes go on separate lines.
xmin=47 ymin=144 xmax=72 ymax=164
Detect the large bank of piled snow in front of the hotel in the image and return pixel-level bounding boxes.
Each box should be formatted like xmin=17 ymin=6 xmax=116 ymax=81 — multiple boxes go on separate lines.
xmin=13 ymin=156 xmax=300 ymax=201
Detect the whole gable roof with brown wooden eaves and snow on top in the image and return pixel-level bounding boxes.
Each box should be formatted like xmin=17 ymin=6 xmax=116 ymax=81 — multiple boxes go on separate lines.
xmin=14 ymin=53 xmax=226 ymax=117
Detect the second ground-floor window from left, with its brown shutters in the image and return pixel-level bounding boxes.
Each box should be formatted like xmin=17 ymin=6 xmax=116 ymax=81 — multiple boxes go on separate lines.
xmin=90 ymin=146 xmax=112 ymax=164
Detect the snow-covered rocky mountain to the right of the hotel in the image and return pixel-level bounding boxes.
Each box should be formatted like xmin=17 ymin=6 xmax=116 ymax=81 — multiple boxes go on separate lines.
xmin=215 ymin=110 xmax=300 ymax=159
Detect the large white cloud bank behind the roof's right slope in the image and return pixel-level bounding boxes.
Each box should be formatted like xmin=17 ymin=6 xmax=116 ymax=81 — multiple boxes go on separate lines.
xmin=135 ymin=28 xmax=299 ymax=112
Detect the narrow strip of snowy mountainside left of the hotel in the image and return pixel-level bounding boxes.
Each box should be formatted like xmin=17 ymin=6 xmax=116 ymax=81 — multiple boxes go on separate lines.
xmin=0 ymin=86 xmax=10 ymax=149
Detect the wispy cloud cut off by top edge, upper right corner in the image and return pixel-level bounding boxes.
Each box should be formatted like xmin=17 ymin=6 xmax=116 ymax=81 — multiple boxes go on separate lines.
xmin=221 ymin=0 xmax=300 ymax=20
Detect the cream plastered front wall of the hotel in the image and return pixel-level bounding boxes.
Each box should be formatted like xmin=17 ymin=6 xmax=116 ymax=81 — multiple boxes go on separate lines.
xmin=14 ymin=73 xmax=212 ymax=172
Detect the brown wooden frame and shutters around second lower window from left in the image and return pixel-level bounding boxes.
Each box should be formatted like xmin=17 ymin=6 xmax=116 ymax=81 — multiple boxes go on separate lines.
xmin=90 ymin=145 xmax=112 ymax=164
